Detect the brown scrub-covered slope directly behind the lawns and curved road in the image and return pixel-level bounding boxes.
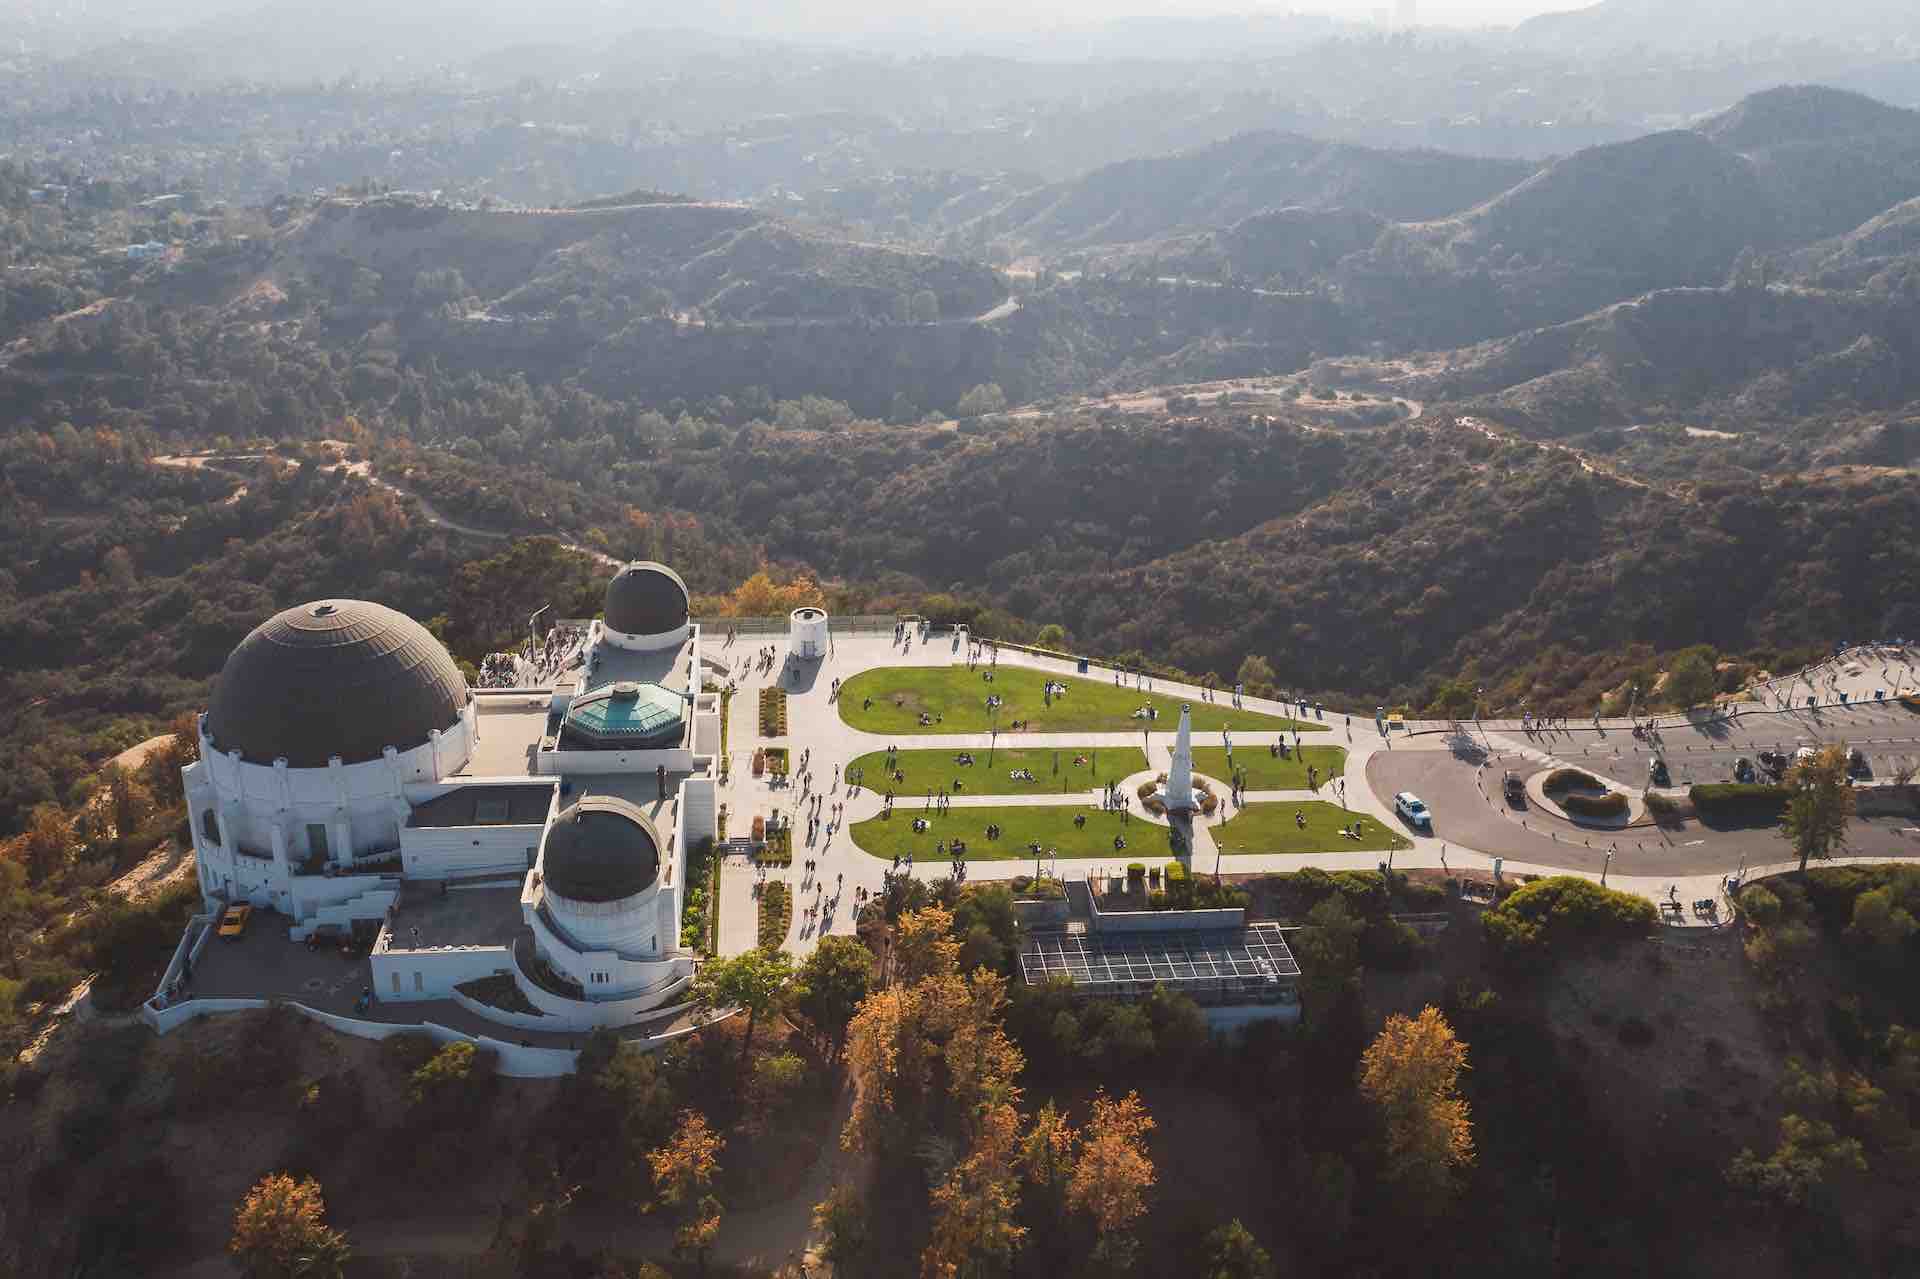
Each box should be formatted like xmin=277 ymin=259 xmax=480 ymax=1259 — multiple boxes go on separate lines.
xmin=1036 ymin=419 xmax=1920 ymax=711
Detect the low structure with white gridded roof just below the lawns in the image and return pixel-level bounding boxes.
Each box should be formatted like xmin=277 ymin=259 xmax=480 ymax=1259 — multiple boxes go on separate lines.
xmin=1020 ymin=924 xmax=1300 ymax=995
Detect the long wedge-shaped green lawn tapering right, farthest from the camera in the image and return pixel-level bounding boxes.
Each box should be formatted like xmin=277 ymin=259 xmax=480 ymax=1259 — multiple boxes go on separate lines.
xmin=839 ymin=666 xmax=1327 ymax=736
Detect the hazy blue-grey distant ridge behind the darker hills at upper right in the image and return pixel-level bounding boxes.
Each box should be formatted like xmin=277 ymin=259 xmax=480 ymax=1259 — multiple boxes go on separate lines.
xmin=973 ymin=133 xmax=1534 ymax=253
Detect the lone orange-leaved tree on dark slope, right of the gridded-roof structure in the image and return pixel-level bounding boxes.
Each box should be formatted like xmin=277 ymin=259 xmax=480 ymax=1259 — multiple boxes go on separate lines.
xmin=1359 ymin=1006 xmax=1473 ymax=1212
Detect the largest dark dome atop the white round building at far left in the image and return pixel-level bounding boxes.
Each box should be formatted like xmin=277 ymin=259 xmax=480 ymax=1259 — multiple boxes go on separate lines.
xmin=207 ymin=599 xmax=470 ymax=768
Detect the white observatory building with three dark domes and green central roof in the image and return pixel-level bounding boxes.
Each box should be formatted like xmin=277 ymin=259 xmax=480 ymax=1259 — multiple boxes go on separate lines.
xmin=182 ymin=563 xmax=720 ymax=1031
